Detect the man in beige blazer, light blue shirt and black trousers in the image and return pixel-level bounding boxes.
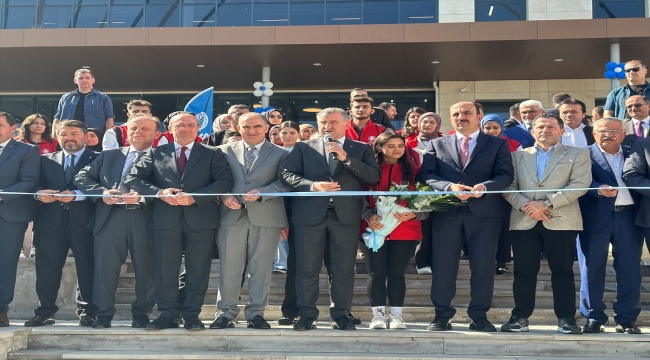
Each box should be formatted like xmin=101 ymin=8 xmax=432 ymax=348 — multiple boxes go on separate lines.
xmin=501 ymin=114 xmax=591 ymax=334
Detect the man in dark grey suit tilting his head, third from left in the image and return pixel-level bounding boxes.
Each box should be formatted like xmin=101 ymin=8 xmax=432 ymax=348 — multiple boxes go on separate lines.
xmin=74 ymin=116 xmax=160 ymax=329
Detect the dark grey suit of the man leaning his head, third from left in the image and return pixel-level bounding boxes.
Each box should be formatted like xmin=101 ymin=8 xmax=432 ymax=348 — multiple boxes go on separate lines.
xmin=74 ymin=147 xmax=156 ymax=317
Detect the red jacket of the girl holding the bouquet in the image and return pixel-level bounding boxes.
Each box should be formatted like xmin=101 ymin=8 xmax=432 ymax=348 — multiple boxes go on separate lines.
xmin=361 ymin=164 xmax=422 ymax=240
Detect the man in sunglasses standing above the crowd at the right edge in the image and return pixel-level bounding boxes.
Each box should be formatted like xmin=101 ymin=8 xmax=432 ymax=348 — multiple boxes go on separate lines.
xmin=604 ymin=60 xmax=650 ymax=119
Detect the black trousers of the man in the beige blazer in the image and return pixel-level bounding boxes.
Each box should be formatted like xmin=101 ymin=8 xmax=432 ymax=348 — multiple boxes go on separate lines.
xmin=511 ymin=221 xmax=578 ymax=319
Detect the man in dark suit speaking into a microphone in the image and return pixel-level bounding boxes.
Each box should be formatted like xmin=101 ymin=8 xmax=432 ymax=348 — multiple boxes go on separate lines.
xmin=282 ymin=108 xmax=380 ymax=330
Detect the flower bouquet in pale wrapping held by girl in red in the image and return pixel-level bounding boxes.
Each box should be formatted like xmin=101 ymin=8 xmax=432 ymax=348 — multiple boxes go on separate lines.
xmin=362 ymin=183 xmax=465 ymax=252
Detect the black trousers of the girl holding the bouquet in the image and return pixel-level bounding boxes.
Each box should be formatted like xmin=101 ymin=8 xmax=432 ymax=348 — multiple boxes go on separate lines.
xmin=361 ymin=240 xmax=419 ymax=307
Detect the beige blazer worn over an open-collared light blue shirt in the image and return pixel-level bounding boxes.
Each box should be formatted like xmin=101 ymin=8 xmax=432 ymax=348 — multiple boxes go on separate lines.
xmin=504 ymin=143 xmax=591 ymax=230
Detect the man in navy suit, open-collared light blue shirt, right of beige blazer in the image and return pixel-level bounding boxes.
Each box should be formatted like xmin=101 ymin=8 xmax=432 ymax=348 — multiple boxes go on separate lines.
xmin=578 ymin=118 xmax=643 ymax=334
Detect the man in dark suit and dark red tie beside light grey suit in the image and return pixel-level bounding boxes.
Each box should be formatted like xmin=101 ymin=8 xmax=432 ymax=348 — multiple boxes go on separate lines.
xmin=123 ymin=112 xmax=233 ymax=330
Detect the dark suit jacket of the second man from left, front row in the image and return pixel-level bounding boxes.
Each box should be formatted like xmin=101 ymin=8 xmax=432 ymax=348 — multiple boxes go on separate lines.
xmin=34 ymin=148 xmax=98 ymax=231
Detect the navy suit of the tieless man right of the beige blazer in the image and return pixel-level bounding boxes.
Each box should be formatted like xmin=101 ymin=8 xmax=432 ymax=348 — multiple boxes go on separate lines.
xmin=578 ymin=144 xmax=642 ymax=324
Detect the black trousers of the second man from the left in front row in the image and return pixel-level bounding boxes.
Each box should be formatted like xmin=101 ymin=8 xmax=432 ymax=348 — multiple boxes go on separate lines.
xmin=34 ymin=211 xmax=97 ymax=318
